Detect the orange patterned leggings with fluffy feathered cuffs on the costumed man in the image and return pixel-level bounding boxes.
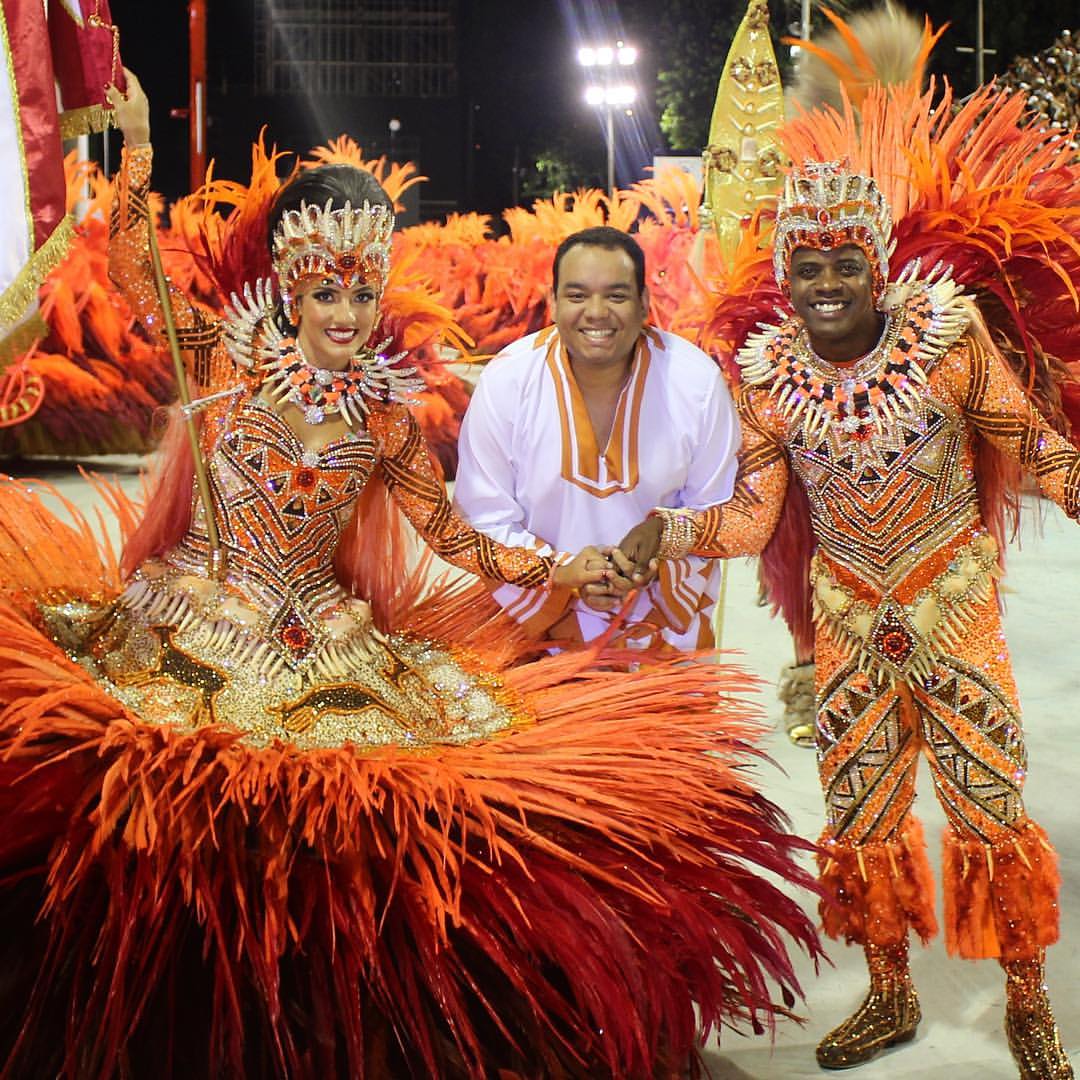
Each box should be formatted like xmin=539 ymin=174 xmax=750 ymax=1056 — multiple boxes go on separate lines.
xmin=816 ymin=600 xmax=1059 ymax=960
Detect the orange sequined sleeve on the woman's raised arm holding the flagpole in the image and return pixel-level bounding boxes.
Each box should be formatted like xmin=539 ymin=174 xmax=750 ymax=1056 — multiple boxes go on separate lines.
xmin=109 ymin=146 xmax=220 ymax=386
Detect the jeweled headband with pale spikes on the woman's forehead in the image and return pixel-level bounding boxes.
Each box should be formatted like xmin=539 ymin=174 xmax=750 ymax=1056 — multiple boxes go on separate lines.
xmin=273 ymin=201 xmax=394 ymax=310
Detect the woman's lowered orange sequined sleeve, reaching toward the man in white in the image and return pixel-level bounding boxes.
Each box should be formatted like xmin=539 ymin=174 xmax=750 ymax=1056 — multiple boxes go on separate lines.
xmin=367 ymin=405 xmax=556 ymax=589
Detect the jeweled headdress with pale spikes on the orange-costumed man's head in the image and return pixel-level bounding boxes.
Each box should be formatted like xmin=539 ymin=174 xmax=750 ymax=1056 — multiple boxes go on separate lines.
xmin=772 ymin=161 xmax=892 ymax=297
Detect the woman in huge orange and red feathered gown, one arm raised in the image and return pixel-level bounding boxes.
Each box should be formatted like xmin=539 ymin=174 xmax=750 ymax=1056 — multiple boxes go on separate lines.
xmin=0 ymin=71 xmax=816 ymax=1078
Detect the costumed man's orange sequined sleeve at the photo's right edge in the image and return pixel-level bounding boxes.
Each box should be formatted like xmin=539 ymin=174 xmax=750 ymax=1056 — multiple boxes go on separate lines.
xmin=935 ymin=338 xmax=1080 ymax=519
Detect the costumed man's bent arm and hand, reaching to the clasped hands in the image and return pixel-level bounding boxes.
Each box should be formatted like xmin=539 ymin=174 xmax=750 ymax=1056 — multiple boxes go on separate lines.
xmin=619 ymin=388 xmax=787 ymax=565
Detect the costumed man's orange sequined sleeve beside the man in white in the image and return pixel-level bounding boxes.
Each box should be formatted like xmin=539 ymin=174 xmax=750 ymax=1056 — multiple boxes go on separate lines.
xmin=689 ymin=387 xmax=787 ymax=558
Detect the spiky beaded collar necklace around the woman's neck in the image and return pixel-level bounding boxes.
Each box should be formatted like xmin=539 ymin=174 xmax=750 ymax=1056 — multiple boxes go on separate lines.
xmin=259 ymin=337 xmax=424 ymax=427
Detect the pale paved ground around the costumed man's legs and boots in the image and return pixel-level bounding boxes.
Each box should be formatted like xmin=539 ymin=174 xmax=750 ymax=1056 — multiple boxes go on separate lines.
xmin=25 ymin=460 xmax=1080 ymax=1080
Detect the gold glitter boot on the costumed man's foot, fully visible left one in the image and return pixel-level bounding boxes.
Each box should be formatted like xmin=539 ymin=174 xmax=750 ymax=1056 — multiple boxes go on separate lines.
xmin=818 ymin=940 xmax=922 ymax=1069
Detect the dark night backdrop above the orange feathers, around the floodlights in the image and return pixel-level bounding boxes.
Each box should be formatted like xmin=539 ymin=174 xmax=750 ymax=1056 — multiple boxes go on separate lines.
xmin=105 ymin=0 xmax=1080 ymax=219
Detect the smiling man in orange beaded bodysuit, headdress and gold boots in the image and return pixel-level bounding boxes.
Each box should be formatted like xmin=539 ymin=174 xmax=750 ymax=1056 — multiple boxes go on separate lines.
xmin=622 ymin=162 xmax=1080 ymax=1078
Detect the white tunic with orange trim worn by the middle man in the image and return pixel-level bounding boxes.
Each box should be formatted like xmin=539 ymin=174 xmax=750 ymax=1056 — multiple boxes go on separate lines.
xmin=455 ymin=326 xmax=740 ymax=648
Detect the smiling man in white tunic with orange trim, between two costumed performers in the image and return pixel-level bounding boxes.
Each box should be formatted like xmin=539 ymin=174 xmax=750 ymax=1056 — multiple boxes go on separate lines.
xmin=455 ymin=227 xmax=740 ymax=649
